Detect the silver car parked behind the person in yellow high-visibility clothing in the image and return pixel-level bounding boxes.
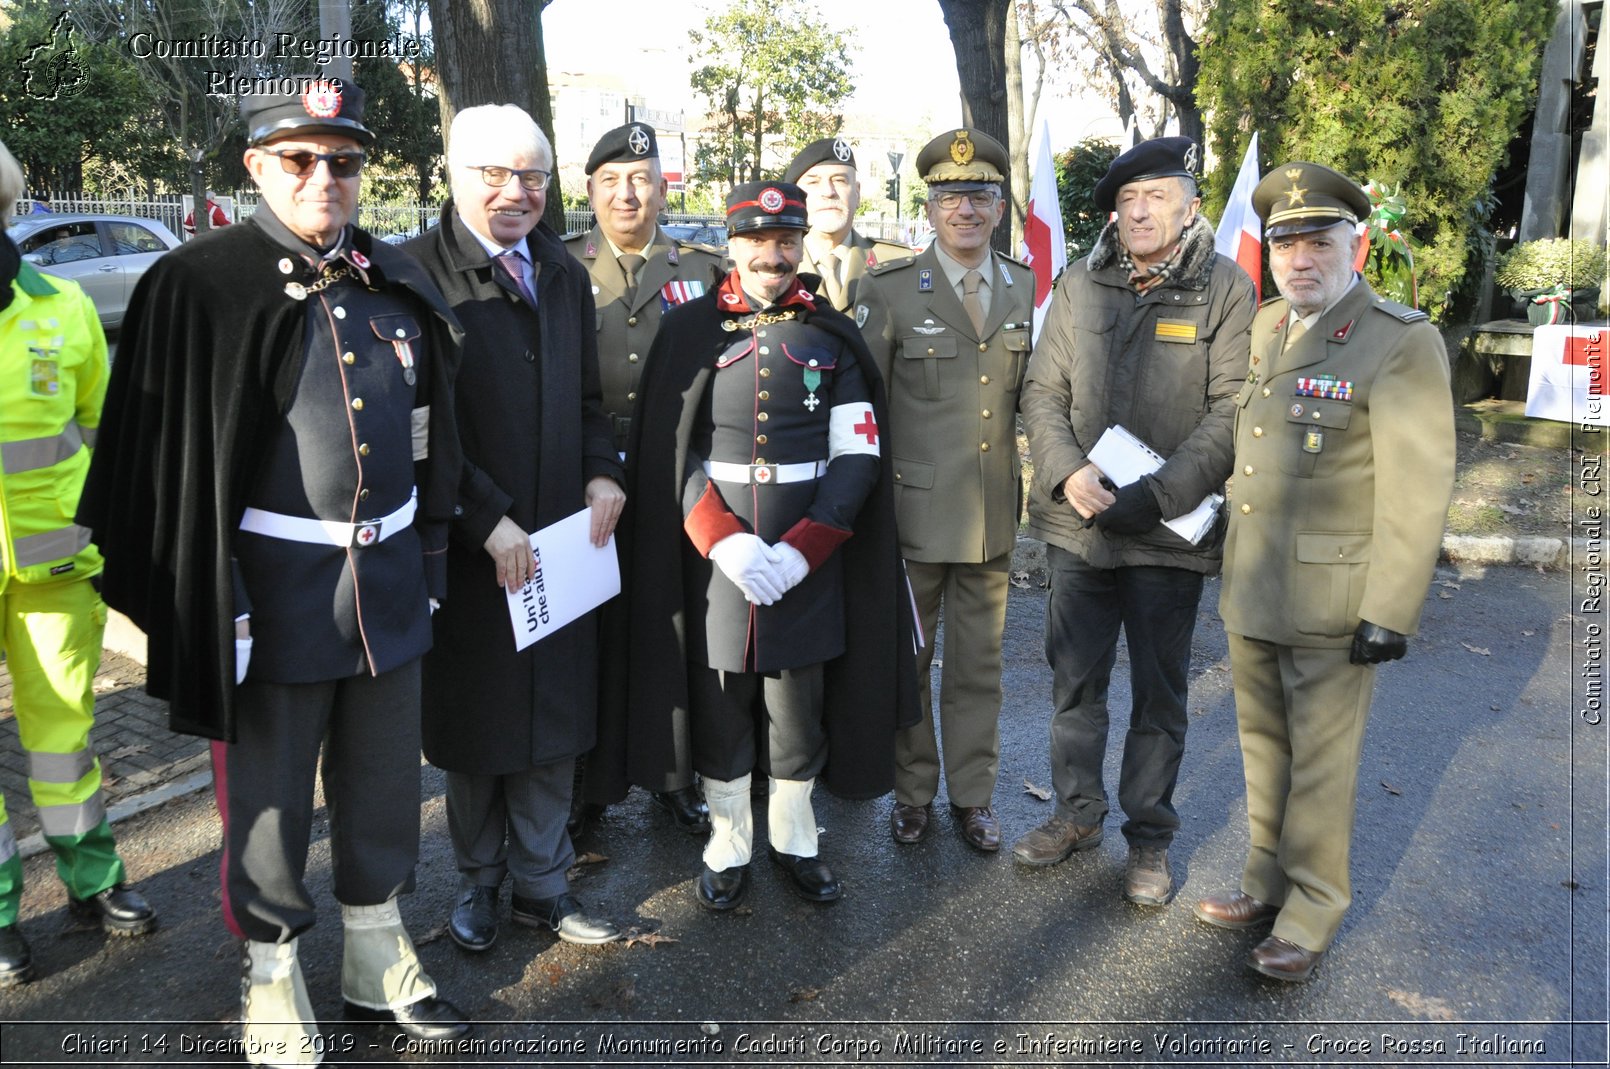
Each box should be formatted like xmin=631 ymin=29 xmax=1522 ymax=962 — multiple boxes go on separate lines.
xmin=6 ymin=214 xmax=179 ymax=330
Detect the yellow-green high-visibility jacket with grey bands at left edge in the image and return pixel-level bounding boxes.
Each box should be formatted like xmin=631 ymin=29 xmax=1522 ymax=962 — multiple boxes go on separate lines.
xmin=0 ymin=262 xmax=106 ymax=591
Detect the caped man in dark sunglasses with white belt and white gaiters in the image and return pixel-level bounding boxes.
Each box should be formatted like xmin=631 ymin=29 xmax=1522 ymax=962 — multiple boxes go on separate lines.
xmin=81 ymin=82 xmax=467 ymax=1064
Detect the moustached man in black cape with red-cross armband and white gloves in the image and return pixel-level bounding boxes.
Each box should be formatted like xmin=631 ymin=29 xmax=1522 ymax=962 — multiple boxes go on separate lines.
xmin=626 ymin=182 xmax=916 ymax=910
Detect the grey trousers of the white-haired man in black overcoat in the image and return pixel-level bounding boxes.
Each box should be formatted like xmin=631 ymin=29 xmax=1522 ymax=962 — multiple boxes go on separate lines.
xmin=448 ymin=757 xmax=576 ymax=898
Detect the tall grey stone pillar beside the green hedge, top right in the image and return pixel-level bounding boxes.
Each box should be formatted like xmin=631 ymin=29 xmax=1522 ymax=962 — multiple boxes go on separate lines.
xmin=1518 ymin=0 xmax=1584 ymax=241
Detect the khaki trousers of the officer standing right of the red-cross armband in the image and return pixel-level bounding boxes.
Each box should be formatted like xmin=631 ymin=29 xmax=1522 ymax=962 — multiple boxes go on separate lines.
xmin=895 ymin=552 xmax=1011 ymax=807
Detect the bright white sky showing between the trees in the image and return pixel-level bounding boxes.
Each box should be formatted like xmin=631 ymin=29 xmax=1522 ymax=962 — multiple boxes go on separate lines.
xmin=543 ymin=0 xmax=1121 ymax=148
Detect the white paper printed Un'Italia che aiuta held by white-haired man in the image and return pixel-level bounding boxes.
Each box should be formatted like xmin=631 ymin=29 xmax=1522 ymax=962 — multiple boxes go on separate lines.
xmin=509 ymin=509 xmax=620 ymax=650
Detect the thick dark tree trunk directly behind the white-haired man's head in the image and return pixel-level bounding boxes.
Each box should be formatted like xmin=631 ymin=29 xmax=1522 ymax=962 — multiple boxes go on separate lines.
xmin=430 ymin=0 xmax=565 ymax=233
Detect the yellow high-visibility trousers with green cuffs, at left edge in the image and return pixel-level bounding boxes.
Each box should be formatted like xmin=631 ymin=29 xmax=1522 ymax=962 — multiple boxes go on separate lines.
xmin=0 ymin=578 xmax=124 ymax=927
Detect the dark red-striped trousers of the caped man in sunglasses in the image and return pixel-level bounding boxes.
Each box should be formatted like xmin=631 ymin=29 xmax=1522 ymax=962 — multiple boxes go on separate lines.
xmin=213 ymin=660 xmax=420 ymax=943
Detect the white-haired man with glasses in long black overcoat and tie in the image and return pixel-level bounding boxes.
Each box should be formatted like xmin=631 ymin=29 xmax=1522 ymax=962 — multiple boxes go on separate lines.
xmin=406 ymin=105 xmax=625 ymax=951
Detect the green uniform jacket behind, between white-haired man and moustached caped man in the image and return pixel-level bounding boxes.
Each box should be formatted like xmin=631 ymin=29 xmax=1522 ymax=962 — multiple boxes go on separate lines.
xmin=565 ymin=225 xmax=726 ymax=451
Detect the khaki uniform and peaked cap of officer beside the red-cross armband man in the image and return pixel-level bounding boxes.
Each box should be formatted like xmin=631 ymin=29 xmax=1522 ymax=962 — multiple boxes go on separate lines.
xmin=855 ymin=132 xmax=1034 ymax=817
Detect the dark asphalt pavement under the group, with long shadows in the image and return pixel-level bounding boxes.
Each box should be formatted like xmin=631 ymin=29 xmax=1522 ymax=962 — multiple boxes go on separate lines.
xmin=0 ymin=565 xmax=1607 ymax=1066
